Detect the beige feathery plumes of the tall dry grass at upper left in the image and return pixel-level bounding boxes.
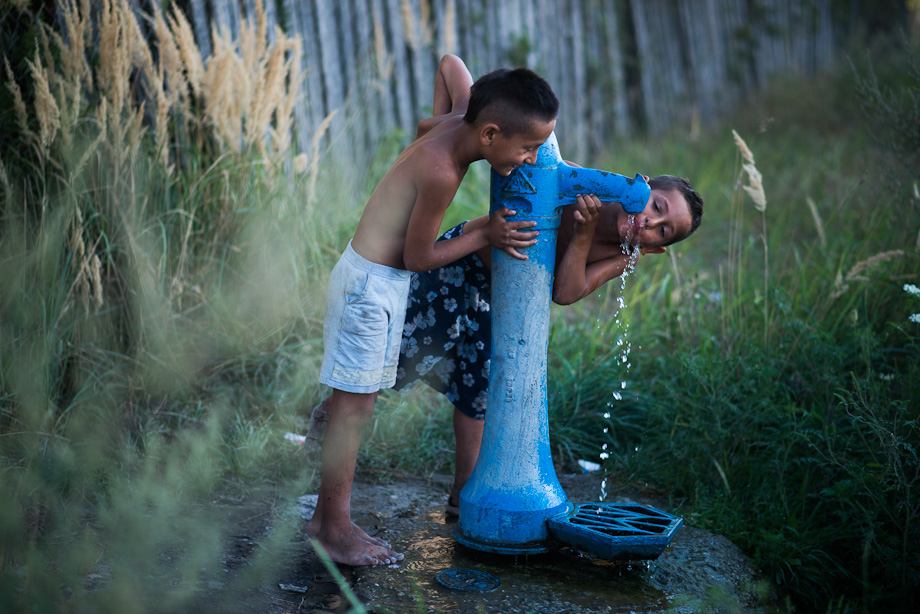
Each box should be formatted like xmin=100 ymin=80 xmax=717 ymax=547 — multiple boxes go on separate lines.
xmin=4 ymin=0 xmax=319 ymax=328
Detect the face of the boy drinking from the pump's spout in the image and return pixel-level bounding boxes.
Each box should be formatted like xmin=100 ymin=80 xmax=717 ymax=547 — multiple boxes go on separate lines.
xmin=602 ymin=189 xmax=693 ymax=247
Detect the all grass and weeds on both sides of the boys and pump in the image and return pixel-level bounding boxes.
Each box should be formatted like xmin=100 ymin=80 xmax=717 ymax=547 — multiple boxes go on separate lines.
xmin=0 ymin=2 xmax=920 ymax=613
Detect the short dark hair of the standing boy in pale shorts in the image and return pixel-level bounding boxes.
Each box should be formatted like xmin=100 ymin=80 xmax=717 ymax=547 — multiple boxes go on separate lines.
xmin=463 ymin=68 xmax=559 ymax=136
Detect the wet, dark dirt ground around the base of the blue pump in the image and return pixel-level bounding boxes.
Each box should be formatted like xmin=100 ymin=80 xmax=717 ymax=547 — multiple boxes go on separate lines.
xmin=201 ymin=474 xmax=776 ymax=614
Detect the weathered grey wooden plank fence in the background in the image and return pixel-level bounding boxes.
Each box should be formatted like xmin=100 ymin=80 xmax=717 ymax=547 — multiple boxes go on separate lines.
xmin=180 ymin=0 xmax=842 ymax=162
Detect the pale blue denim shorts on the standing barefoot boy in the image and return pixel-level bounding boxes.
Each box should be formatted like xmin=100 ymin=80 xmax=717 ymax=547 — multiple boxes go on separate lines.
xmin=319 ymin=241 xmax=412 ymax=393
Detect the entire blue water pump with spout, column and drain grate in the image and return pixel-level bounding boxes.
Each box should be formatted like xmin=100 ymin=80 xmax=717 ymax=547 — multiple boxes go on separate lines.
xmin=454 ymin=134 xmax=681 ymax=558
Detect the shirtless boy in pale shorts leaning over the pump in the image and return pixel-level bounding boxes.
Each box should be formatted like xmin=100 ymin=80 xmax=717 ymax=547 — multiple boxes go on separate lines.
xmin=307 ymin=55 xmax=559 ymax=565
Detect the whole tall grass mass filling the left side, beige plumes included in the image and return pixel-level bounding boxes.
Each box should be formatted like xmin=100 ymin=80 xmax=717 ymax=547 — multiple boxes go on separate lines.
xmin=0 ymin=0 xmax=360 ymax=612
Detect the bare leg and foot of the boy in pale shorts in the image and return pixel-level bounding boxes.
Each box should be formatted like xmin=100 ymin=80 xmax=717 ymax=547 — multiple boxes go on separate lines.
xmin=308 ymin=390 xmax=404 ymax=565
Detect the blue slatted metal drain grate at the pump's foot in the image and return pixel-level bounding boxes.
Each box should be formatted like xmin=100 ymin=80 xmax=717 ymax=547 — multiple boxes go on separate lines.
xmin=548 ymin=503 xmax=683 ymax=560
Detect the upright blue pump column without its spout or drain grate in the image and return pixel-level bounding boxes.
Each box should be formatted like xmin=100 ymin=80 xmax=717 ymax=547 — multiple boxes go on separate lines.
xmin=455 ymin=135 xmax=567 ymax=554
